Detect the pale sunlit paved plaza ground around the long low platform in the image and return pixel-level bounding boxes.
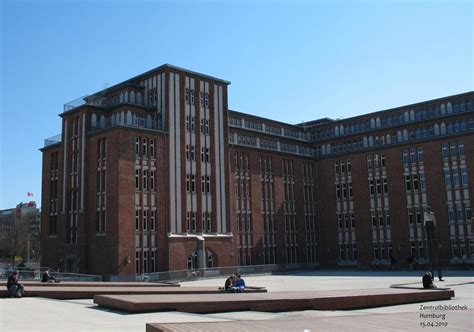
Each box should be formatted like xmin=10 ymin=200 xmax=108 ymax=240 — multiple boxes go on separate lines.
xmin=0 ymin=271 xmax=474 ymax=332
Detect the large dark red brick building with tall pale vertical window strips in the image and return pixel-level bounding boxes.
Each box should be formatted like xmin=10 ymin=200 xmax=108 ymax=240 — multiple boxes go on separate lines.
xmin=41 ymin=65 xmax=474 ymax=275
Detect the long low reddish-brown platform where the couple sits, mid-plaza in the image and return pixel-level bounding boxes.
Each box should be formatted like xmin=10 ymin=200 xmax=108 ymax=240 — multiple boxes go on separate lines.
xmin=94 ymin=288 xmax=454 ymax=313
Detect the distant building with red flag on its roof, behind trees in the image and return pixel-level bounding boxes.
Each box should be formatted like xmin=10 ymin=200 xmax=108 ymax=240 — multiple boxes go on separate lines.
xmin=0 ymin=201 xmax=41 ymax=263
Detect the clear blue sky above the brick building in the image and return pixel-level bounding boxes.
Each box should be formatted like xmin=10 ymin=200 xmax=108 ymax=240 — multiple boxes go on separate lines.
xmin=0 ymin=0 xmax=474 ymax=209
